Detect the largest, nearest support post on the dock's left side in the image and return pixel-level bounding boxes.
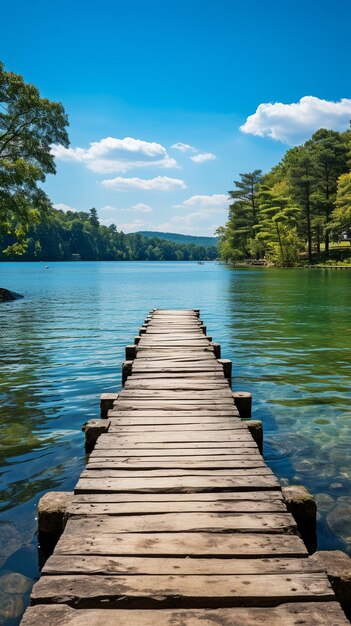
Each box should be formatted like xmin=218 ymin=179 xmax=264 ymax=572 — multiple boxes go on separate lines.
xmin=38 ymin=491 xmax=73 ymax=562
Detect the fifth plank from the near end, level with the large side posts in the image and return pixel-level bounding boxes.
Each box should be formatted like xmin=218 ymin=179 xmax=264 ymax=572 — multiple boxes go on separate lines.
xmin=66 ymin=512 xmax=296 ymax=535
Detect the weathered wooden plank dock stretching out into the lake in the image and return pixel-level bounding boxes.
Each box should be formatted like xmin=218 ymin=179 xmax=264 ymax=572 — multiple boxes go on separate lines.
xmin=22 ymin=310 xmax=349 ymax=626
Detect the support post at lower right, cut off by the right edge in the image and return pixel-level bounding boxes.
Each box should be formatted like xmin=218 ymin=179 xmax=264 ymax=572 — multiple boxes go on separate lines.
xmin=308 ymin=550 xmax=351 ymax=619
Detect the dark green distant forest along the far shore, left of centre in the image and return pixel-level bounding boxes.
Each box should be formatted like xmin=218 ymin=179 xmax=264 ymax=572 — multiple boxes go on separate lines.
xmin=0 ymin=208 xmax=218 ymax=261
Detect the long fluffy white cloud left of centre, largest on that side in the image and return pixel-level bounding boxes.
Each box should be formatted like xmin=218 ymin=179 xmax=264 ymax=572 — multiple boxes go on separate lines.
xmin=51 ymin=137 xmax=178 ymax=174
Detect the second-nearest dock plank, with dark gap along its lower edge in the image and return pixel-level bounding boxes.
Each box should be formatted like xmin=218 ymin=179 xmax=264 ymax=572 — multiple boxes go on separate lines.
xmin=31 ymin=572 xmax=334 ymax=609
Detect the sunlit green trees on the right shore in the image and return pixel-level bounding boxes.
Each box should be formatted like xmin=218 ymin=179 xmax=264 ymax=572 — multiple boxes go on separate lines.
xmin=217 ymin=128 xmax=351 ymax=266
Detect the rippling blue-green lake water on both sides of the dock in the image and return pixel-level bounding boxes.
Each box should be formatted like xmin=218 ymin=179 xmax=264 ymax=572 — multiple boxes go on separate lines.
xmin=0 ymin=262 xmax=351 ymax=626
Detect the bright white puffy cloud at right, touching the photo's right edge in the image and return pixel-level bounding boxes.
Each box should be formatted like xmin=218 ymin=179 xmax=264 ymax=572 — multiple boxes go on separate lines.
xmin=240 ymin=96 xmax=351 ymax=145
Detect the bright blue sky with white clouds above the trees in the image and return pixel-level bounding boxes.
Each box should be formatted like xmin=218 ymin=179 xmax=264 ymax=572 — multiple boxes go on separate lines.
xmin=0 ymin=0 xmax=351 ymax=235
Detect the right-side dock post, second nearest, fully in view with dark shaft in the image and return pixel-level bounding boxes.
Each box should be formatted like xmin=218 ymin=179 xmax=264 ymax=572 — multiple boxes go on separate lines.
xmin=282 ymin=485 xmax=317 ymax=554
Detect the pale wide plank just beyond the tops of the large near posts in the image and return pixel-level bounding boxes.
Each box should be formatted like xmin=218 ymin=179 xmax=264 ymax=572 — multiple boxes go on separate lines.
xmin=75 ymin=475 xmax=280 ymax=493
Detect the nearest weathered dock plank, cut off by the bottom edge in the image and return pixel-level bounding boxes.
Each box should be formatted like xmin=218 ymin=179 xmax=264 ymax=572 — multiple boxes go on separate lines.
xmin=21 ymin=602 xmax=349 ymax=626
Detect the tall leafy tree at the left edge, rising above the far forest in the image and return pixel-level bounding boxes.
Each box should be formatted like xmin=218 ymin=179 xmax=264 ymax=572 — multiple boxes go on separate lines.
xmin=0 ymin=62 xmax=69 ymax=252
